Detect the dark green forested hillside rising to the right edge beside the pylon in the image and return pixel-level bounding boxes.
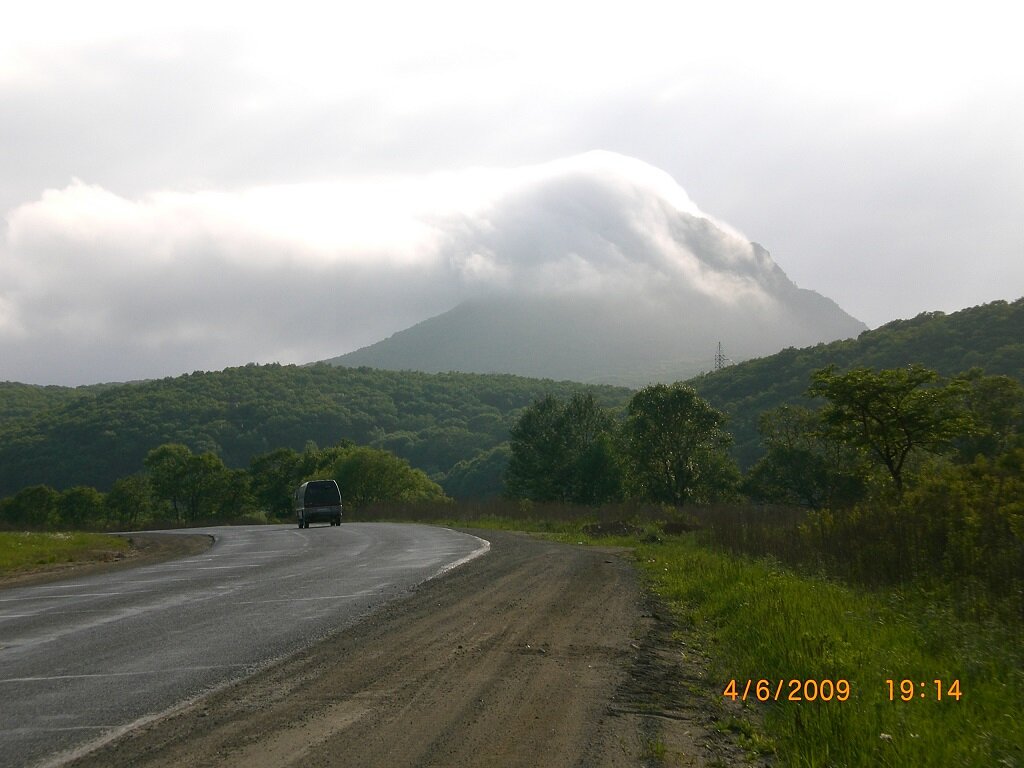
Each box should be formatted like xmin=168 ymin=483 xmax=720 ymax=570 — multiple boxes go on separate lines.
xmin=689 ymin=299 xmax=1024 ymax=467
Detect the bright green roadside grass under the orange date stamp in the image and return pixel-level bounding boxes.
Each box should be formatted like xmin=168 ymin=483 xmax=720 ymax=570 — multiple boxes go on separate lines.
xmin=635 ymin=538 xmax=1024 ymax=768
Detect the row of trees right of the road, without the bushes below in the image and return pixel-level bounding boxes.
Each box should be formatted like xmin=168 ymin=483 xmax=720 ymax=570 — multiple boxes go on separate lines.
xmin=506 ymin=365 xmax=1024 ymax=509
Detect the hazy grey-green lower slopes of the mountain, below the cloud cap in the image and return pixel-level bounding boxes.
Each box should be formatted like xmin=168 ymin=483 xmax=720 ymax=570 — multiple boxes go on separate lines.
xmin=326 ymin=274 xmax=864 ymax=387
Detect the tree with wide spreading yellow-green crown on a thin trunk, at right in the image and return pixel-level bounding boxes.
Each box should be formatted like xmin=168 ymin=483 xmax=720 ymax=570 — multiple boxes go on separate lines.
xmin=808 ymin=366 xmax=970 ymax=496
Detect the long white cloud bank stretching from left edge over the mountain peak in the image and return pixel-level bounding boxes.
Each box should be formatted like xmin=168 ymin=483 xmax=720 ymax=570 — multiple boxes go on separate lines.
xmin=0 ymin=153 xmax=794 ymax=383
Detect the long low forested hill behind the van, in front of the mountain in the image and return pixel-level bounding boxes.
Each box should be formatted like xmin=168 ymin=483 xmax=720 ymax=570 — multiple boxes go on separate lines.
xmin=0 ymin=365 xmax=630 ymax=496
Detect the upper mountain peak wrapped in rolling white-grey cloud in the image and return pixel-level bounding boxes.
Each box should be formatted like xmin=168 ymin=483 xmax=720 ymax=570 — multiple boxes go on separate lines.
xmin=438 ymin=152 xmax=787 ymax=302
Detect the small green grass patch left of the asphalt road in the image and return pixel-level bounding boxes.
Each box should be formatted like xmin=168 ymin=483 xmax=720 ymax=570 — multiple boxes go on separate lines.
xmin=0 ymin=532 xmax=130 ymax=575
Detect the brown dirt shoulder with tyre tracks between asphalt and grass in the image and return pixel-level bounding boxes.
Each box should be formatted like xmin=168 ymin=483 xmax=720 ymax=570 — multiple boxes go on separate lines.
xmin=58 ymin=530 xmax=761 ymax=768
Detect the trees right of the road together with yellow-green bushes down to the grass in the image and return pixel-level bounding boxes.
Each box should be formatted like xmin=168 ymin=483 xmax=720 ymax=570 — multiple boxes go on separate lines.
xmin=506 ymin=366 xmax=1024 ymax=615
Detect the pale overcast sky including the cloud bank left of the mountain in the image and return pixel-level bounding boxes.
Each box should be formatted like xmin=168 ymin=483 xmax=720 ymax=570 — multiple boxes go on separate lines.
xmin=0 ymin=0 xmax=1024 ymax=384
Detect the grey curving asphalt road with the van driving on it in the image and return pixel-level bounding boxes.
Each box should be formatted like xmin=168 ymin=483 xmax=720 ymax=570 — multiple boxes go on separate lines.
xmin=0 ymin=523 xmax=487 ymax=766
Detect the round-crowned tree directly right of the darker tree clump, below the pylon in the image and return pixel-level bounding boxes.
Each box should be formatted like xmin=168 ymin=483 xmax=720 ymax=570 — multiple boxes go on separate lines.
xmin=625 ymin=383 xmax=738 ymax=505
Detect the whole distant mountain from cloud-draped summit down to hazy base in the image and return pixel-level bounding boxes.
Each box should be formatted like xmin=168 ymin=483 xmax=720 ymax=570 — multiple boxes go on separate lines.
xmin=327 ymin=153 xmax=865 ymax=386
